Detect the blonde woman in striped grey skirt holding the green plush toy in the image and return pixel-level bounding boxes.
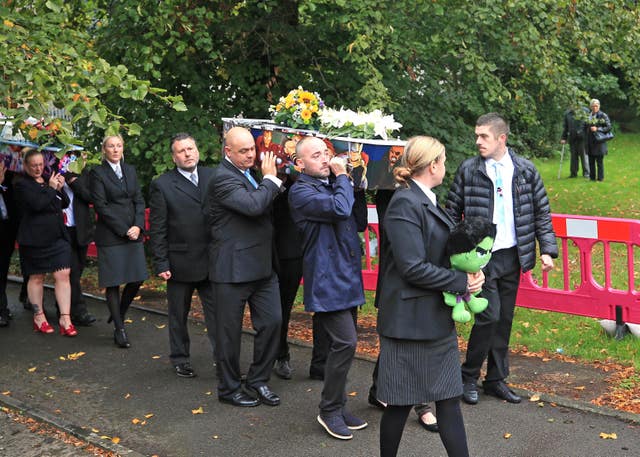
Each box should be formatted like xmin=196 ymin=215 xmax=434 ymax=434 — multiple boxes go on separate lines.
xmin=377 ymin=136 xmax=484 ymax=457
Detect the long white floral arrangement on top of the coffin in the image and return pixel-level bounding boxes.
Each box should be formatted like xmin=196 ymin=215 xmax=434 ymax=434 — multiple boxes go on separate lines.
xmin=320 ymin=108 xmax=402 ymax=140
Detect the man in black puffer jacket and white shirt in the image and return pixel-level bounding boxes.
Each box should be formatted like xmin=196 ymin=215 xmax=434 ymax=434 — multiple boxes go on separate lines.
xmin=446 ymin=113 xmax=558 ymax=404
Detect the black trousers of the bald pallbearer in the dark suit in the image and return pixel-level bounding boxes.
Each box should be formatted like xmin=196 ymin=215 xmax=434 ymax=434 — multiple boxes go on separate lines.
xmin=213 ymin=273 xmax=282 ymax=396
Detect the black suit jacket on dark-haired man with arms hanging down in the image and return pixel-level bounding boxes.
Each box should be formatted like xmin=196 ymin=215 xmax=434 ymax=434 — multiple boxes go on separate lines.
xmin=149 ymin=167 xmax=213 ymax=282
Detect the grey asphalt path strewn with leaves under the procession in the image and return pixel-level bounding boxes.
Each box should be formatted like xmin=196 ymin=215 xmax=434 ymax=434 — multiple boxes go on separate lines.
xmin=0 ymin=284 xmax=640 ymax=457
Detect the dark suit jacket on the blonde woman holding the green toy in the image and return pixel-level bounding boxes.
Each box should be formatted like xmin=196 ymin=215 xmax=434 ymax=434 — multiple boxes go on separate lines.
xmin=378 ymin=182 xmax=467 ymax=340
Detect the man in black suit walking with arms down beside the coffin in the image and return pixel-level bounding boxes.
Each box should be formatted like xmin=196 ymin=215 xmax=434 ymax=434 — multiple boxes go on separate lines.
xmin=149 ymin=133 xmax=215 ymax=378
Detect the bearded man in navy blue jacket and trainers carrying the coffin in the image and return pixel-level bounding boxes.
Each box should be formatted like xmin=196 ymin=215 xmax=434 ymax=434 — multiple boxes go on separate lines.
xmin=289 ymin=137 xmax=367 ymax=440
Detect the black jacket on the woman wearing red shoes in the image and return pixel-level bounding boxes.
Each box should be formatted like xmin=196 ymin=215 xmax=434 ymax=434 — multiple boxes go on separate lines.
xmin=15 ymin=175 xmax=69 ymax=246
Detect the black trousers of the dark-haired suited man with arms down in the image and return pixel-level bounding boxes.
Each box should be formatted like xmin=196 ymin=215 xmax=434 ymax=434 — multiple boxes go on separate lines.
xmin=167 ymin=279 xmax=217 ymax=365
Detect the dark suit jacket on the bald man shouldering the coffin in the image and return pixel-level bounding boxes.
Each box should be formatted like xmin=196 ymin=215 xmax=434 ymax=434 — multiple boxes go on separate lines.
xmin=207 ymin=159 xmax=280 ymax=283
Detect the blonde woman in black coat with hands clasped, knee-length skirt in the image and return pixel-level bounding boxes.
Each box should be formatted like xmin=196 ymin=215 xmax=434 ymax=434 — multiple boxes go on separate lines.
xmin=90 ymin=135 xmax=149 ymax=348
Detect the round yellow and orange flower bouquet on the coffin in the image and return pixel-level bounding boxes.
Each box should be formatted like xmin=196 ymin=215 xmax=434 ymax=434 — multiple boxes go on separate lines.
xmin=269 ymin=86 xmax=324 ymax=130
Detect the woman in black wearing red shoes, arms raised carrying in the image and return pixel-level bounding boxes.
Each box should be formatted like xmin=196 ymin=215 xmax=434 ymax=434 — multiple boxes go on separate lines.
xmin=15 ymin=149 xmax=78 ymax=336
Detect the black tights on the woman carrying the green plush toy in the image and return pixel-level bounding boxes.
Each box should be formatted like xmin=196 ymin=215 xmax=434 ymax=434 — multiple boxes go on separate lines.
xmin=380 ymin=397 xmax=469 ymax=457
